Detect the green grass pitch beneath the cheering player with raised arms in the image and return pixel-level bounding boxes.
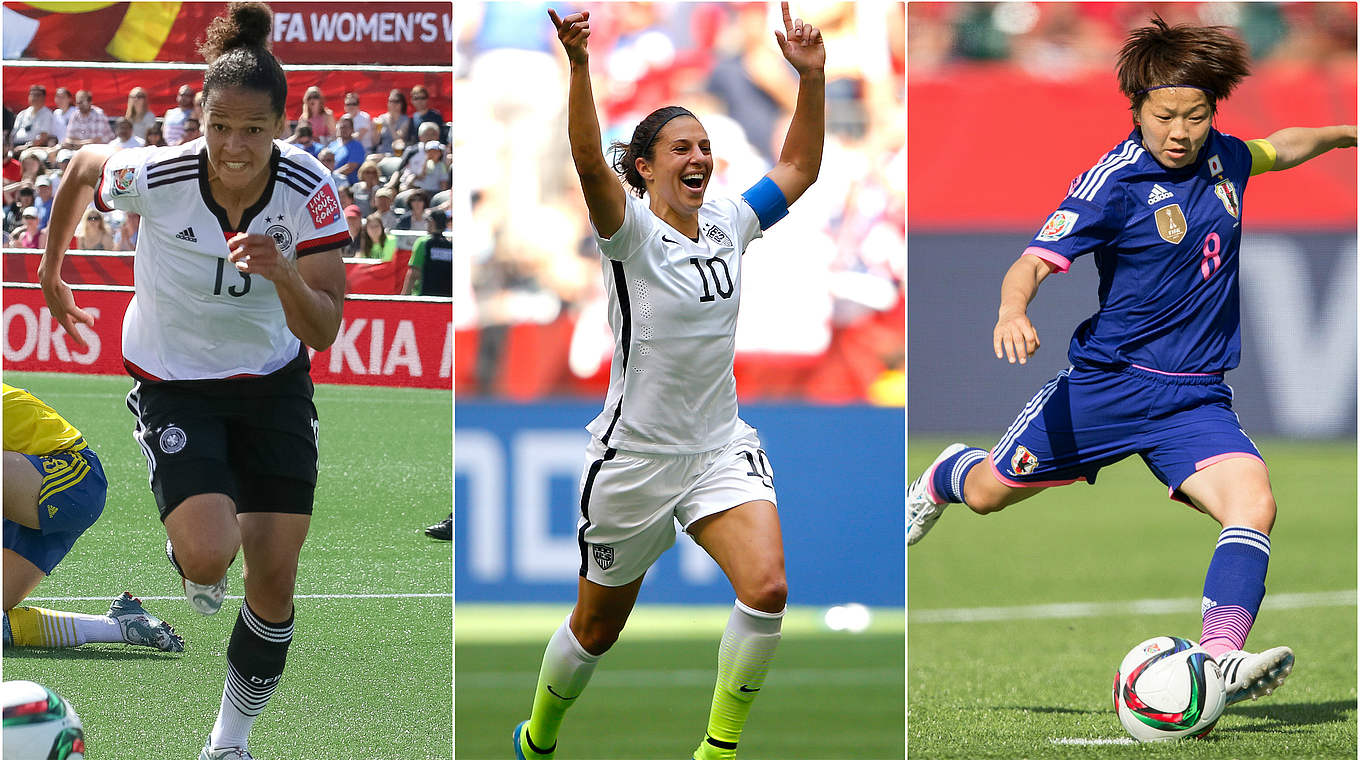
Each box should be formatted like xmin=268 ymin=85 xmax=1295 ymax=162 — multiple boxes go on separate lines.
xmin=454 ymin=606 xmax=904 ymax=760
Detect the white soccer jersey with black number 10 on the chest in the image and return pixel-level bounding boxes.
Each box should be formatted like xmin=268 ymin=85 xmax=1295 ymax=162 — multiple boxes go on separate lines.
xmin=586 ymin=194 xmax=760 ymax=454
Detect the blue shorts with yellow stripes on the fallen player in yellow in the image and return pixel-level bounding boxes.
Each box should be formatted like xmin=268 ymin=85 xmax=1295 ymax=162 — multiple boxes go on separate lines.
xmin=4 ymin=447 xmax=109 ymax=574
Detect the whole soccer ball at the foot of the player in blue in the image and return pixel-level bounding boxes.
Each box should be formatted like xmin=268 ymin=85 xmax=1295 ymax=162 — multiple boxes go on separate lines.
xmin=1114 ymin=636 xmax=1228 ymax=741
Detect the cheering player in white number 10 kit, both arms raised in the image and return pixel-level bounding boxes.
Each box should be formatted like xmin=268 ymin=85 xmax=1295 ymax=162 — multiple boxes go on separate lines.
xmin=514 ymin=4 xmax=826 ymax=760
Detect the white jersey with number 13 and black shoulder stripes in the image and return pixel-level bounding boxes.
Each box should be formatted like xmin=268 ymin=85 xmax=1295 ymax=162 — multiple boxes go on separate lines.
xmin=95 ymin=137 xmax=350 ymax=381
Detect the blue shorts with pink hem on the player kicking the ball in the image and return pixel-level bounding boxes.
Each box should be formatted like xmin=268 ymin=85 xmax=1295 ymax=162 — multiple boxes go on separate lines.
xmin=990 ymin=367 xmax=1261 ymax=504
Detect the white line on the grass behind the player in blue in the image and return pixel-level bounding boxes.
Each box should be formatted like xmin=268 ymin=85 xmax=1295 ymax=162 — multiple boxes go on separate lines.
xmin=907 ymin=589 xmax=1356 ymax=623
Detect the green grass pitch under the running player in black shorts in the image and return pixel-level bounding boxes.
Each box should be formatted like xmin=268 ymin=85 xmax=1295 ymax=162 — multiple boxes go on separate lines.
xmin=3 ymin=373 xmax=453 ymax=760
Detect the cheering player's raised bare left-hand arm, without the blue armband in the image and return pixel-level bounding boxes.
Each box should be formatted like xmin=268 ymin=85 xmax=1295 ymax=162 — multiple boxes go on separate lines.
xmin=548 ymin=8 xmax=627 ymax=238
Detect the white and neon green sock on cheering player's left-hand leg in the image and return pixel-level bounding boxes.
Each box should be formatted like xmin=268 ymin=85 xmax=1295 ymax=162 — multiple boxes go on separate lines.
xmin=520 ymin=616 xmax=600 ymax=757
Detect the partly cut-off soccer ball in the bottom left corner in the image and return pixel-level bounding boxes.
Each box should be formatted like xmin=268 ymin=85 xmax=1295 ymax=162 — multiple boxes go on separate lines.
xmin=0 ymin=681 xmax=84 ymax=760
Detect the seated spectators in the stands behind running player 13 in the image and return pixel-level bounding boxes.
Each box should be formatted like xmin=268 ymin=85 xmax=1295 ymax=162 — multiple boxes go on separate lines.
xmin=4 ymin=83 xmax=452 ymax=295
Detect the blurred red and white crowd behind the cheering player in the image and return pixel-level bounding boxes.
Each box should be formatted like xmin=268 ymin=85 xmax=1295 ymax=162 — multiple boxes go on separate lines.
xmin=454 ymin=3 xmax=906 ymax=402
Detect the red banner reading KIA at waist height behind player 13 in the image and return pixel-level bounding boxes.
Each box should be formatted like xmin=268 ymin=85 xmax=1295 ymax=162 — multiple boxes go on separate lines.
xmin=3 ymin=284 xmax=453 ymax=390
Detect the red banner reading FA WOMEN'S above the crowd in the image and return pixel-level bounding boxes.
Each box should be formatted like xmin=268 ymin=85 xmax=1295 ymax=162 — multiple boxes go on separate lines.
xmin=4 ymin=0 xmax=453 ymax=67
